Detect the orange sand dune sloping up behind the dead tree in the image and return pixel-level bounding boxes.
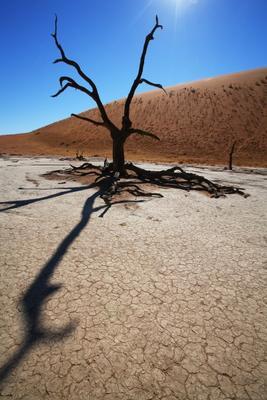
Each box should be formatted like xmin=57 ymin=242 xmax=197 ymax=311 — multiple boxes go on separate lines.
xmin=0 ymin=68 xmax=267 ymax=167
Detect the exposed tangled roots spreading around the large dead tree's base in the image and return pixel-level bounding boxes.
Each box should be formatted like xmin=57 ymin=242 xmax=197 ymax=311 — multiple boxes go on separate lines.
xmin=45 ymin=160 xmax=249 ymax=204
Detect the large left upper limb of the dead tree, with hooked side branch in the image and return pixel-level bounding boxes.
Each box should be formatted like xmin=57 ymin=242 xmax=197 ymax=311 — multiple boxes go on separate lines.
xmin=51 ymin=15 xmax=117 ymax=129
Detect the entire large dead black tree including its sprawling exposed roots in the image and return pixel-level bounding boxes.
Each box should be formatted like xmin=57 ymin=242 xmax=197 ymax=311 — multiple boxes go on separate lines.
xmin=52 ymin=16 xmax=247 ymax=203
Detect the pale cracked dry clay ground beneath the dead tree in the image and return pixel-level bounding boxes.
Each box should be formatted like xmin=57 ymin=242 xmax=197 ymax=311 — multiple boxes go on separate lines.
xmin=0 ymin=158 xmax=267 ymax=400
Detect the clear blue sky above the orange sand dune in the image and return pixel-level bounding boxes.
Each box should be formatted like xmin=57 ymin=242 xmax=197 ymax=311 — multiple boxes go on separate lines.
xmin=0 ymin=0 xmax=267 ymax=134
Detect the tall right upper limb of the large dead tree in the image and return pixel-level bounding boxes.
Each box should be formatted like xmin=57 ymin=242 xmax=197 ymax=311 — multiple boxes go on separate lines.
xmin=122 ymin=15 xmax=163 ymax=130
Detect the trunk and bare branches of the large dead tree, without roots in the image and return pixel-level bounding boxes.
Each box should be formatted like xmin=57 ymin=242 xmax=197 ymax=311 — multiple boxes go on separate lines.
xmin=52 ymin=16 xmax=166 ymax=176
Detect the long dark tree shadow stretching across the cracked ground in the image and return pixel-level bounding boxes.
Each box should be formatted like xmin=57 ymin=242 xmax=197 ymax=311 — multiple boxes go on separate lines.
xmin=0 ymin=178 xmax=144 ymax=382
